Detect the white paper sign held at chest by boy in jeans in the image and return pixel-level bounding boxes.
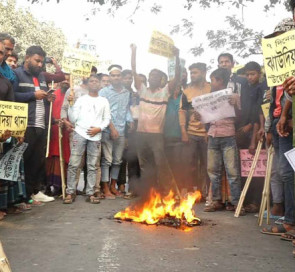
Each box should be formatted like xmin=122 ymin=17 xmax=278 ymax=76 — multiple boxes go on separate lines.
xmin=192 ymin=88 xmax=236 ymax=124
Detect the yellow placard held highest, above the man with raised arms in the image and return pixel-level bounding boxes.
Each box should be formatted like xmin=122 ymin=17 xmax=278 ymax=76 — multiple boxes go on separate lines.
xmin=149 ymin=31 xmax=174 ymax=58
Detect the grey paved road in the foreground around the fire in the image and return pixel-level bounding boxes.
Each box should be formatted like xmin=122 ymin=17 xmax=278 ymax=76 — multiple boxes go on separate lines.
xmin=0 ymin=196 xmax=295 ymax=272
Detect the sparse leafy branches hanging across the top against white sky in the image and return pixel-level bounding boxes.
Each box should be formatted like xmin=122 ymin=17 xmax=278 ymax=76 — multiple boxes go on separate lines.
xmin=27 ymin=0 xmax=290 ymax=58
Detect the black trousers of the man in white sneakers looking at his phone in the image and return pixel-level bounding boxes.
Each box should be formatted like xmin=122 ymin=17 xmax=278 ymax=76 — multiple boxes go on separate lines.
xmin=24 ymin=127 xmax=46 ymax=199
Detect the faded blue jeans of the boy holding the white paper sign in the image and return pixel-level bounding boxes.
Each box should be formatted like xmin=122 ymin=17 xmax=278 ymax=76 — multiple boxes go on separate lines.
xmin=207 ymin=136 xmax=241 ymax=205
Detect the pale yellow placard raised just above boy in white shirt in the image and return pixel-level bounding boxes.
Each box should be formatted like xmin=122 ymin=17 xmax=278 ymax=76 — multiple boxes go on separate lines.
xmin=62 ymin=47 xmax=97 ymax=77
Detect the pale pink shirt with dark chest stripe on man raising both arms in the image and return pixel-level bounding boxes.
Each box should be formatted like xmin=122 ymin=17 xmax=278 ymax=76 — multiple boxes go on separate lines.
xmin=137 ymin=84 xmax=170 ymax=133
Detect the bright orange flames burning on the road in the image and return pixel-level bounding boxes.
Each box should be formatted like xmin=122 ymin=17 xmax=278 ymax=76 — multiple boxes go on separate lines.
xmin=114 ymin=189 xmax=201 ymax=226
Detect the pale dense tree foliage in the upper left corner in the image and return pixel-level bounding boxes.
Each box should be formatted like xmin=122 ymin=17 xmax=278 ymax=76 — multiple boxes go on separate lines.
xmin=0 ymin=0 xmax=67 ymax=60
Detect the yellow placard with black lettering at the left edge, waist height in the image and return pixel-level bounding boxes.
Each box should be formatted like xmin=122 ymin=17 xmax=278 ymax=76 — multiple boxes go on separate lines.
xmin=0 ymin=101 xmax=28 ymax=137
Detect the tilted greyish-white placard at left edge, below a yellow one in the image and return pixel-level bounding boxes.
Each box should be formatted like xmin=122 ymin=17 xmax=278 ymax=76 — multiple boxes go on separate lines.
xmin=0 ymin=143 xmax=28 ymax=181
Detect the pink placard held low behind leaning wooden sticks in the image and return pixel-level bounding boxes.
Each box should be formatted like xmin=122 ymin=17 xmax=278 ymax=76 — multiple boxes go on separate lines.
xmin=240 ymin=149 xmax=267 ymax=177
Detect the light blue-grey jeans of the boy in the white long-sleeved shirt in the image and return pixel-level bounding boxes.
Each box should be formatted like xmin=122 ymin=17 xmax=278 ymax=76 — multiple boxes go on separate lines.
xmin=67 ymin=132 xmax=100 ymax=195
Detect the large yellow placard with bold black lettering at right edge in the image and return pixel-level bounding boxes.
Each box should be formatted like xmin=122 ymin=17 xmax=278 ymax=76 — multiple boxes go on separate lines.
xmin=262 ymin=30 xmax=295 ymax=87
